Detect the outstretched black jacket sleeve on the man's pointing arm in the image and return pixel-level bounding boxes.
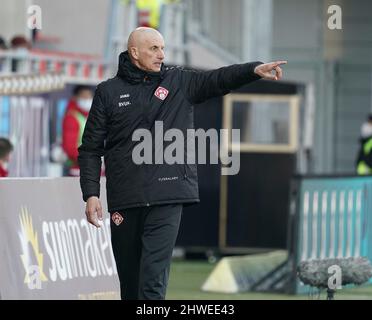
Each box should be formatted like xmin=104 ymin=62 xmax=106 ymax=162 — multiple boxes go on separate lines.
xmin=181 ymin=61 xmax=262 ymax=103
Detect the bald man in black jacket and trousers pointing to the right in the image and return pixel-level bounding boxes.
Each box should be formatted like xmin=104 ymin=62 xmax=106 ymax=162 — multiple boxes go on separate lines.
xmin=78 ymin=27 xmax=286 ymax=300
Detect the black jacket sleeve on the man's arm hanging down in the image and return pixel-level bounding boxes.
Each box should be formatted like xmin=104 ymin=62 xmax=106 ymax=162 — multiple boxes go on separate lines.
xmin=78 ymin=86 xmax=107 ymax=201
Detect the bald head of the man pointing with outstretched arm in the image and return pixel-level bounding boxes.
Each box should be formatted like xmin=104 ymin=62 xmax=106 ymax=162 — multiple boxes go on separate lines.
xmin=128 ymin=27 xmax=164 ymax=72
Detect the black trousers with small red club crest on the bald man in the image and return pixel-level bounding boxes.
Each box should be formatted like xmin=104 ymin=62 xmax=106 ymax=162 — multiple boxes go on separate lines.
xmin=111 ymin=204 xmax=183 ymax=300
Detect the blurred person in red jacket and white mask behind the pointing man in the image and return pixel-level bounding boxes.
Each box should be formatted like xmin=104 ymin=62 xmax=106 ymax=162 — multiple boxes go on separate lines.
xmin=62 ymin=85 xmax=93 ymax=177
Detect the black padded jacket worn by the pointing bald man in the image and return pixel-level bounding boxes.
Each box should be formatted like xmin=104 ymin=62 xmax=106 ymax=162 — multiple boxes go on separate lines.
xmin=78 ymin=52 xmax=262 ymax=212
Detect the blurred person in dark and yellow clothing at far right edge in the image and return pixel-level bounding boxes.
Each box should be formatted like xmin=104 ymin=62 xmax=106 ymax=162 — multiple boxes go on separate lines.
xmin=356 ymin=114 xmax=372 ymax=175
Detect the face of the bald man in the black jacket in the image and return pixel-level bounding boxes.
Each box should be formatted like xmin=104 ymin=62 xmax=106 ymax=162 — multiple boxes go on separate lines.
xmin=132 ymin=33 xmax=164 ymax=72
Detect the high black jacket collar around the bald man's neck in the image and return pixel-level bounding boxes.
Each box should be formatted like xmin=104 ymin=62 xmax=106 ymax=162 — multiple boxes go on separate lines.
xmin=117 ymin=51 xmax=165 ymax=83
